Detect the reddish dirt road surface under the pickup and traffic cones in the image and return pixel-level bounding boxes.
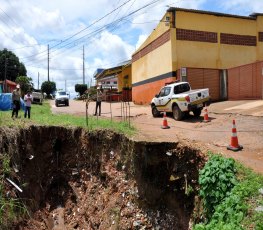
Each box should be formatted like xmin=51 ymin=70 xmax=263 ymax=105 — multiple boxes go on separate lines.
xmin=50 ymin=100 xmax=263 ymax=173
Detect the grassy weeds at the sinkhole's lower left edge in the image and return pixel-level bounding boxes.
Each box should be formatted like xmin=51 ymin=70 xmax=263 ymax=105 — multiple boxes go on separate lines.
xmin=0 ymin=155 xmax=28 ymax=229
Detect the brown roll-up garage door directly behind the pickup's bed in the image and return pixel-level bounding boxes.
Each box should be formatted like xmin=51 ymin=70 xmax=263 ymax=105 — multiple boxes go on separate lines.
xmin=187 ymin=68 xmax=220 ymax=101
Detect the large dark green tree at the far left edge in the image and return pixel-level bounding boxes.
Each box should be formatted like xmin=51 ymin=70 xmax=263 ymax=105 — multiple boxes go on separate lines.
xmin=0 ymin=49 xmax=27 ymax=82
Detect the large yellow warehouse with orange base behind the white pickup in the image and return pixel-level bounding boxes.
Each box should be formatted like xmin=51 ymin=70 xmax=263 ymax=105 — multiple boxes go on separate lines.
xmin=132 ymin=8 xmax=263 ymax=104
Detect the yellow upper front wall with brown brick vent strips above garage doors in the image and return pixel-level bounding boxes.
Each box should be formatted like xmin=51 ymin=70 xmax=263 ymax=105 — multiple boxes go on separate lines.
xmin=175 ymin=11 xmax=263 ymax=69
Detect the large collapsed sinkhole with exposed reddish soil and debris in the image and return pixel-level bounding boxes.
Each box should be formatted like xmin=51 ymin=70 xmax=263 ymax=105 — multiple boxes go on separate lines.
xmin=0 ymin=126 xmax=204 ymax=229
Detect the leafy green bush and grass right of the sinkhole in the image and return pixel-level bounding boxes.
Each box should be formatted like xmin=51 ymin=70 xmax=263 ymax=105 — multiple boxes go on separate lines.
xmin=194 ymin=155 xmax=263 ymax=230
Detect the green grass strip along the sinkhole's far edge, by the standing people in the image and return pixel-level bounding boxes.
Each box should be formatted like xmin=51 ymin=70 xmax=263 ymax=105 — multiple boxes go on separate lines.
xmin=0 ymin=99 xmax=135 ymax=135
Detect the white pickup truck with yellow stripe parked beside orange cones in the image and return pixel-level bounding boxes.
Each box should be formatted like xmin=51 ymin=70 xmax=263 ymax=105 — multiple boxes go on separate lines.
xmin=151 ymin=82 xmax=210 ymax=121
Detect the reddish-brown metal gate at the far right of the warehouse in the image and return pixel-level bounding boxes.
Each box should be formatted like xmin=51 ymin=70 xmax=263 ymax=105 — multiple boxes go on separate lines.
xmin=228 ymin=63 xmax=262 ymax=100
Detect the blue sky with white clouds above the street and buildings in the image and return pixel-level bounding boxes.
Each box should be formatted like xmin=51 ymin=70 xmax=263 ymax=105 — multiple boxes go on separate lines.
xmin=0 ymin=0 xmax=263 ymax=97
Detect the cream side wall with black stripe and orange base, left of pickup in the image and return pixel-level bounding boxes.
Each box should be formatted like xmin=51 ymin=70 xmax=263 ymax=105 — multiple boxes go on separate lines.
xmin=132 ymin=31 xmax=175 ymax=104
